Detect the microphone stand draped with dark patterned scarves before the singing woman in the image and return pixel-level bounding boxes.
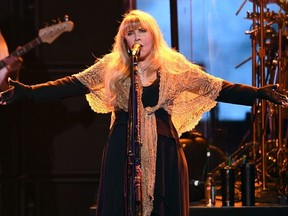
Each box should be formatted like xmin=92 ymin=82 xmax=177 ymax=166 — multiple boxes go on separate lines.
xmin=125 ymin=53 xmax=142 ymax=216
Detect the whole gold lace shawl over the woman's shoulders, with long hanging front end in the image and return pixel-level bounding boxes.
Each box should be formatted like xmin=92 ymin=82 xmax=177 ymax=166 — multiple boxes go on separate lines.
xmin=74 ymin=55 xmax=222 ymax=216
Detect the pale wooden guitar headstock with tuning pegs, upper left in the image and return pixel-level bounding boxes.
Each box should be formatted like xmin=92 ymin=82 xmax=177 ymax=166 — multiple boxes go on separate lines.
xmin=38 ymin=16 xmax=74 ymax=44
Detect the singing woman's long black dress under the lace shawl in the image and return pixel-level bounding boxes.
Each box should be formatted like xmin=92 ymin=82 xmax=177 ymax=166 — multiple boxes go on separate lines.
xmin=97 ymin=79 xmax=189 ymax=216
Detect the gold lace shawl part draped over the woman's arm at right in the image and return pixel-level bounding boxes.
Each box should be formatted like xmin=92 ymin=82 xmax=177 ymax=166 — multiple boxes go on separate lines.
xmin=160 ymin=64 xmax=223 ymax=136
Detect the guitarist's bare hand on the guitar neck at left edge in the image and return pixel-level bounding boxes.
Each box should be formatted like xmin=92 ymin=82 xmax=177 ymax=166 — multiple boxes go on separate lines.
xmin=0 ymin=56 xmax=23 ymax=91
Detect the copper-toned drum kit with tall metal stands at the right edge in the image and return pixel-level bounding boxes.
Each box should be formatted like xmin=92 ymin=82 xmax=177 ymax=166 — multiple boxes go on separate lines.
xmin=180 ymin=0 xmax=288 ymax=204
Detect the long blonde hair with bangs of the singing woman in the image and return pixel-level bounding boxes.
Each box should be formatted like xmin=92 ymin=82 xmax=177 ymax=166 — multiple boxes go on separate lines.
xmin=104 ymin=10 xmax=198 ymax=104
